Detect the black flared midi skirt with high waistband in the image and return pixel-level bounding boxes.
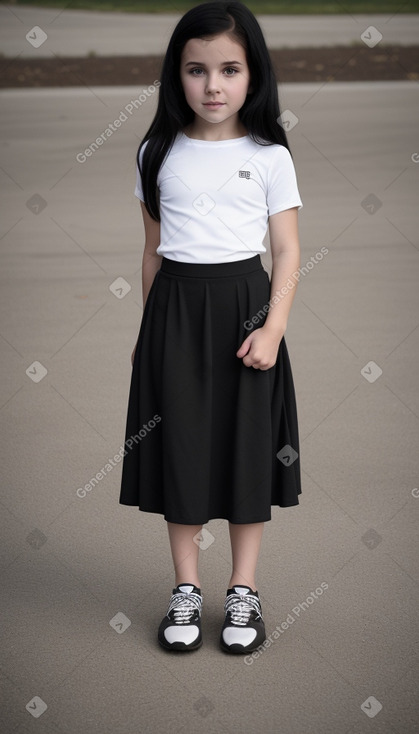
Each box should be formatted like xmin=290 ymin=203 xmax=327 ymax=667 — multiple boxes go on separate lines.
xmin=119 ymin=255 xmax=301 ymax=525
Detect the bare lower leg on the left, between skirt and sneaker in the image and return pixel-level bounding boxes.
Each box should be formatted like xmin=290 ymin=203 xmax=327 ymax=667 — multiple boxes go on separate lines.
xmin=167 ymin=522 xmax=202 ymax=589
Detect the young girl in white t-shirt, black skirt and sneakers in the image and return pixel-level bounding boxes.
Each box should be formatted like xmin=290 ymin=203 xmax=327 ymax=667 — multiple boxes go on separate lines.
xmin=119 ymin=1 xmax=302 ymax=653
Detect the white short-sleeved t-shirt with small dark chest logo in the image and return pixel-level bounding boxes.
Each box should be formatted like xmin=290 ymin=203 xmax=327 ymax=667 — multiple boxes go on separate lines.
xmin=135 ymin=132 xmax=303 ymax=264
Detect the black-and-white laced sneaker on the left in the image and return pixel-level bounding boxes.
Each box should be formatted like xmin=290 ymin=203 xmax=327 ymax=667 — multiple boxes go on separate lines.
xmin=158 ymin=584 xmax=202 ymax=650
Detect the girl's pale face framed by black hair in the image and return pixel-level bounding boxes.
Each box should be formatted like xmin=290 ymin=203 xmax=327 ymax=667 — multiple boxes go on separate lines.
xmin=180 ymin=34 xmax=250 ymax=134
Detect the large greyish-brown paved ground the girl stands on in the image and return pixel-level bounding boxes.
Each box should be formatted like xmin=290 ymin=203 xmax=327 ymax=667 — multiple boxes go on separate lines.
xmin=0 ymin=77 xmax=419 ymax=734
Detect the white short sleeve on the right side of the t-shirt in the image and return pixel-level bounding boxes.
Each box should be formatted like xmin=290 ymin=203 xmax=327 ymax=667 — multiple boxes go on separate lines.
xmin=267 ymin=145 xmax=303 ymax=216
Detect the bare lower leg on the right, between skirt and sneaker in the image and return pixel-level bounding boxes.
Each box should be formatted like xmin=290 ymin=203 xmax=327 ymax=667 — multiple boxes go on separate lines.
xmin=228 ymin=522 xmax=264 ymax=591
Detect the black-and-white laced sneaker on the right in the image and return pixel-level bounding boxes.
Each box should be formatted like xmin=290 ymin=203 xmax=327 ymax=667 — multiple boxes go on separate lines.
xmin=220 ymin=586 xmax=266 ymax=654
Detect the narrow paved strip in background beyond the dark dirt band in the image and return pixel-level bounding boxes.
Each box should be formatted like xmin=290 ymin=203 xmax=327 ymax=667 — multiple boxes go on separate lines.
xmin=0 ymin=3 xmax=419 ymax=58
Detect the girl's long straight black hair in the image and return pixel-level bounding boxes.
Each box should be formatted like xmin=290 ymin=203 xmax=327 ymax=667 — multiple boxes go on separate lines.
xmin=137 ymin=0 xmax=290 ymax=221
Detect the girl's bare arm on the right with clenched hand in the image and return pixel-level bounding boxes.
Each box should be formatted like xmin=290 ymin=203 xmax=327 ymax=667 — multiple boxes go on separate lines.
xmin=237 ymin=207 xmax=300 ymax=370
